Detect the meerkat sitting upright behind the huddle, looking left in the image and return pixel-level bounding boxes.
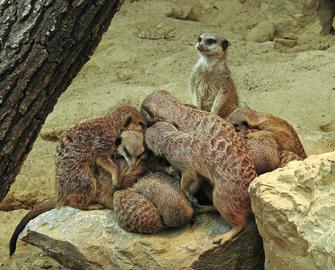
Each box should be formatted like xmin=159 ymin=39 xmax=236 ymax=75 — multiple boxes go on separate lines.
xmin=190 ymin=33 xmax=238 ymax=118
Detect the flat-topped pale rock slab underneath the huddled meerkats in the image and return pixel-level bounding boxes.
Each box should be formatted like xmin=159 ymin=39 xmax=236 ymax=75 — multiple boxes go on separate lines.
xmin=21 ymin=207 xmax=264 ymax=270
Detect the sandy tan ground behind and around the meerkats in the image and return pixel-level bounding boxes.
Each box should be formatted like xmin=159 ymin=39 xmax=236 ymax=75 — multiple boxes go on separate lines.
xmin=0 ymin=0 xmax=335 ymax=269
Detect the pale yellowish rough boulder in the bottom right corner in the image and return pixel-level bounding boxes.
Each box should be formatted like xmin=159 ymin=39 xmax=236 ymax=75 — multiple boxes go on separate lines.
xmin=250 ymin=152 xmax=335 ymax=270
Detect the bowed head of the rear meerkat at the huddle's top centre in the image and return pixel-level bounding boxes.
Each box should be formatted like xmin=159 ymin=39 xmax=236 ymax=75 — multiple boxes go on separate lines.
xmin=141 ymin=90 xmax=177 ymax=125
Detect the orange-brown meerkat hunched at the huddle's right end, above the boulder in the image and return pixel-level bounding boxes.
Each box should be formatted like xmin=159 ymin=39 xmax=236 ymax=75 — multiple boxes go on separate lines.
xmin=227 ymin=104 xmax=307 ymax=160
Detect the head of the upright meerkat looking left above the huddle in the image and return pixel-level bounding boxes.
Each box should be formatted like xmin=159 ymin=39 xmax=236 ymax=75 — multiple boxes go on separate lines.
xmin=195 ymin=33 xmax=229 ymax=57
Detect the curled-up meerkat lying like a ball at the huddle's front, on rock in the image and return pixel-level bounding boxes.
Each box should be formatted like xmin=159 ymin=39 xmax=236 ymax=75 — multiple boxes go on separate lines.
xmin=113 ymin=172 xmax=193 ymax=234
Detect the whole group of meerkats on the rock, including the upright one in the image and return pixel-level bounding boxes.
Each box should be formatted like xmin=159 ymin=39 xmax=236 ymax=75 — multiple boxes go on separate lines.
xmin=10 ymin=33 xmax=306 ymax=255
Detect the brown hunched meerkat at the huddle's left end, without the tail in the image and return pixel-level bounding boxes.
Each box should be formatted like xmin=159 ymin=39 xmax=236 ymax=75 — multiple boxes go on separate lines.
xmin=56 ymin=106 xmax=145 ymax=209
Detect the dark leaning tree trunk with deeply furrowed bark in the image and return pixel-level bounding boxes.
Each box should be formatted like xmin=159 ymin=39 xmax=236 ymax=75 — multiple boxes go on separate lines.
xmin=0 ymin=0 xmax=122 ymax=201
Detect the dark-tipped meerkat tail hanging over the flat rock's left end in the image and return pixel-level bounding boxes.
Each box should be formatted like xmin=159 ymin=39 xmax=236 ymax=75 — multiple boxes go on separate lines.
xmin=9 ymin=200 xmax=56 ymax=256
